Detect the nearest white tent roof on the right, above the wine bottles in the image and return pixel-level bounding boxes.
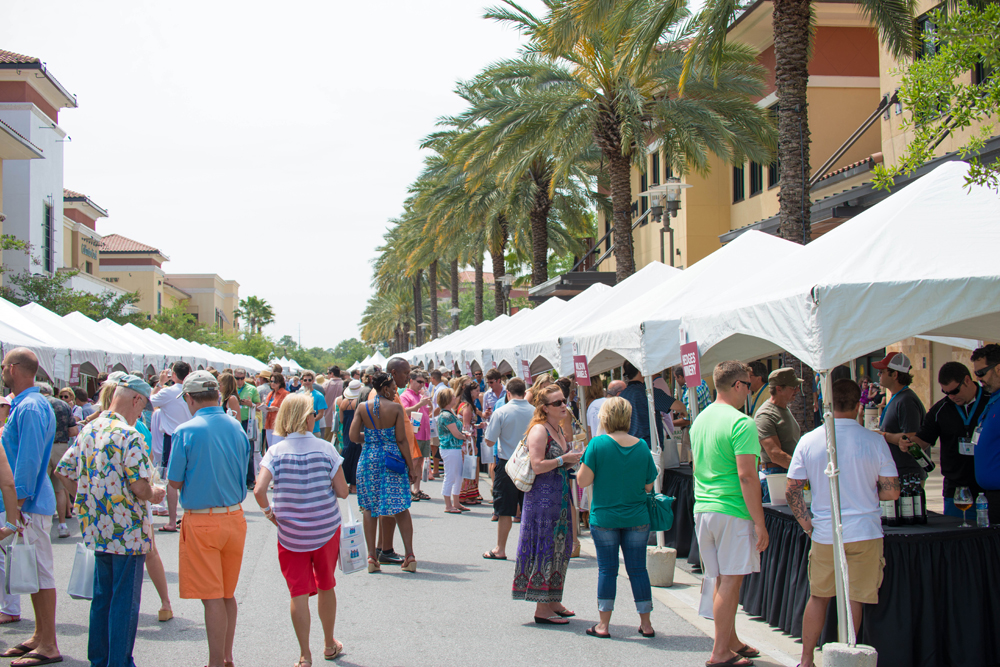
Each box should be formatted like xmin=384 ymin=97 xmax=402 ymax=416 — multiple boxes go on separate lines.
xmin=683 ymin=162 xmax=1000 ymax=370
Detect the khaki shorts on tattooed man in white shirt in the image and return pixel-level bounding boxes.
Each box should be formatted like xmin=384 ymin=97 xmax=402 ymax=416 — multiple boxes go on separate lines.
xmin=809 ymin=537 xmax=885 ymax=604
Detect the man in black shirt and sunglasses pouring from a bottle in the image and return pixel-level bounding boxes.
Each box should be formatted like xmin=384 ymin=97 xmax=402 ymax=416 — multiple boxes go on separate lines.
xmin=901 ymin=361 xmax=990 ymax=517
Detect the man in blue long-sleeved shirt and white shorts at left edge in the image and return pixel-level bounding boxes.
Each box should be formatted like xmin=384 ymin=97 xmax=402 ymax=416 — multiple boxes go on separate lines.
xmin=2 ymin=347 xmax=60 ymax=665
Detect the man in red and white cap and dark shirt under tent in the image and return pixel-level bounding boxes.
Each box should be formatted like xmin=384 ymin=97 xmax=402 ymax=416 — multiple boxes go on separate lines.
xmin=872 ymin=352 xmax=927 ymax=482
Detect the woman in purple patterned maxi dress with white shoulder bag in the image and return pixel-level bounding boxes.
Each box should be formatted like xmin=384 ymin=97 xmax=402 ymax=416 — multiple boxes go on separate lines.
xmin=512 ymin=385 xmax=582 ymax=625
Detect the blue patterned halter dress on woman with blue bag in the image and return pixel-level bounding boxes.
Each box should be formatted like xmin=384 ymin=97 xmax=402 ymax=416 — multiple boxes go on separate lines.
xmin=358 ymin=396 xmax=411 ymax=516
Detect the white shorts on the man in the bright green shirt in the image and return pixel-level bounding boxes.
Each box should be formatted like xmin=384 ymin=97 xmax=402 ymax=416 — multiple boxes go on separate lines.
xmin=694 ymin=512 xmax=760 ymax=577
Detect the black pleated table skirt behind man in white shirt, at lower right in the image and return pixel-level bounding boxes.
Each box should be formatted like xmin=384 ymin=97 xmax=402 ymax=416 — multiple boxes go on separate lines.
xmin=740 ymin=507 xmax=1000 ymax=667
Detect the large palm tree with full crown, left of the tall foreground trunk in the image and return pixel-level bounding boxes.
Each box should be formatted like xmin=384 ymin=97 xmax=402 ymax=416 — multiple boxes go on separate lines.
xmin=478 ymin=0 xmax=773 ymax=281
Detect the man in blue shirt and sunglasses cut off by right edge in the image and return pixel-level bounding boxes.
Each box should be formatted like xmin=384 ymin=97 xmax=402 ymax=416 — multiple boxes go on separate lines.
xmin=972 ymin=343 xmax=1000 ymax=525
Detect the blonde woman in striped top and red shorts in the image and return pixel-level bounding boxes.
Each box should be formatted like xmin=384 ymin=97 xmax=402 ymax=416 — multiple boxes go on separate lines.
xmin=253 ymin=394 xmax=347 ymax=665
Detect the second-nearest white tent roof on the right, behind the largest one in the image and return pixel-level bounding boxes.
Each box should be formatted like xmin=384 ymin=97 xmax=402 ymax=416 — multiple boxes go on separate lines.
xmin=573 ymin=231 xmax=802 ymax=375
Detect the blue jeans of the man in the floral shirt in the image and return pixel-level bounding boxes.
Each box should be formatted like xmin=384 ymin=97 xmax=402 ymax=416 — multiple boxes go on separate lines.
xmin=87 ymin=552 xmax=146 ymax=667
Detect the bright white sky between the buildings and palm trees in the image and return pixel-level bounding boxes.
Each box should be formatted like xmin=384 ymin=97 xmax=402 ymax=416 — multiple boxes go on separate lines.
xmin=0 ymin=0 xmax=543 ymax=347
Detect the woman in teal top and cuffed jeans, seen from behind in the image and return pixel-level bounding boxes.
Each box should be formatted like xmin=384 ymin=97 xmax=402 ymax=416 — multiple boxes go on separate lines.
xmin=576 ymin=396 xmax=656 ymax=639
